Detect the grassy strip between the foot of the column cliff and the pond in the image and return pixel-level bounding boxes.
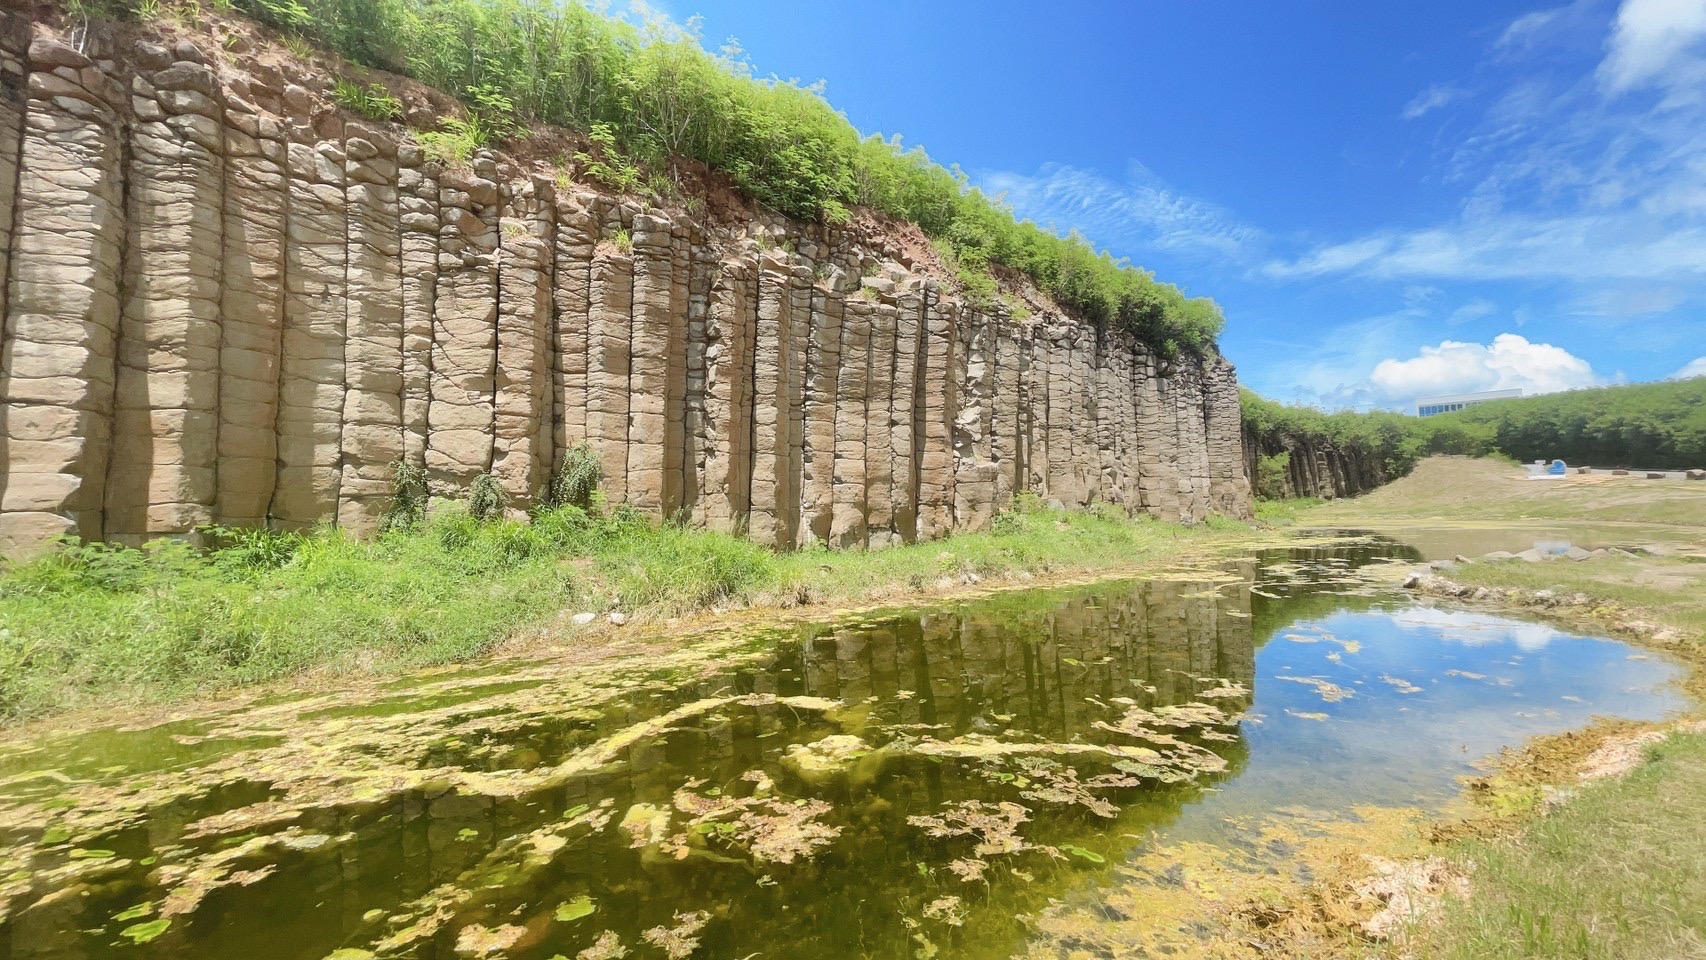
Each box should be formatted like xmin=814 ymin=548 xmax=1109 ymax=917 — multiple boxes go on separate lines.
xmin=0 ymin=498 xmax=1249 ymax=721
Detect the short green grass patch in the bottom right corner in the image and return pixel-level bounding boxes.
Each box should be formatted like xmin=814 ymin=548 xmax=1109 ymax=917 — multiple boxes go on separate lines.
xmin=1413 ymin=733 xmax=1706 ymax=960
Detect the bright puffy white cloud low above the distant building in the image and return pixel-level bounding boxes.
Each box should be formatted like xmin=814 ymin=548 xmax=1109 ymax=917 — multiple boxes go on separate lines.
xmin=1368 ymin=333 xmax=1604 ymax=404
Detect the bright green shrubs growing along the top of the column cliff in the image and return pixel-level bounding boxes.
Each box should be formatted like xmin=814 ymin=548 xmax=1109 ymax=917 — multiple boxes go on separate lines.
xmin=70 ymin=0 xmax=1225 ymax=355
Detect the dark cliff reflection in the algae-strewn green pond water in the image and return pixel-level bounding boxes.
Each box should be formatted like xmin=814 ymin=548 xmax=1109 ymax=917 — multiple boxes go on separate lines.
xmin=0 ymin=569 xmax=1254 ymax=960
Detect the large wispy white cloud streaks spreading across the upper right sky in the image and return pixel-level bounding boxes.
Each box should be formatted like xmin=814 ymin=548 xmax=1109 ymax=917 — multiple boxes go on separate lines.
xmin=1261 ymin=0 xmax=1706 ymax=293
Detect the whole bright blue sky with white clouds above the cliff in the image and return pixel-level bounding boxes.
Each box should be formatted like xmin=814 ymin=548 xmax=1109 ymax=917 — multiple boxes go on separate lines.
xmin=634 ymin=0 xmax=1706 ymax=408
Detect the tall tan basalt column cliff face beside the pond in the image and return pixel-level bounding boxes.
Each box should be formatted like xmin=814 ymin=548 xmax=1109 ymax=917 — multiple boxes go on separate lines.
xmin=0 ymin=12 xmax=1250 ymax=552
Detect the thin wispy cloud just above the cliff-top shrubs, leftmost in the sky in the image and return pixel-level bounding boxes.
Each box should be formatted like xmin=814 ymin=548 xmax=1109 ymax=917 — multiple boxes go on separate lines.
xmin=981 ymin=164 xmax=1266 ymax=263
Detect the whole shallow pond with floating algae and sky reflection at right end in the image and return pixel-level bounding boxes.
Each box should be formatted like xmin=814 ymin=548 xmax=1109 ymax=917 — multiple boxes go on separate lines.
xmin=0 ymin=541 xmax=1680 ymax=960
